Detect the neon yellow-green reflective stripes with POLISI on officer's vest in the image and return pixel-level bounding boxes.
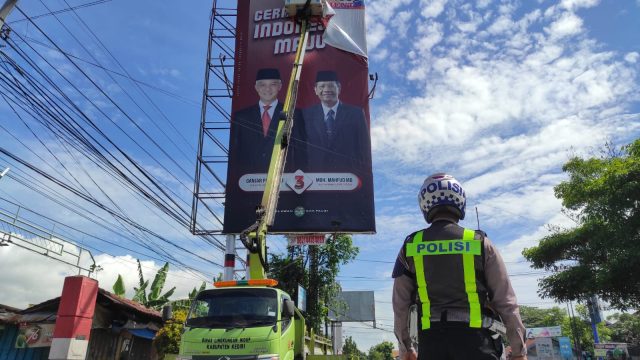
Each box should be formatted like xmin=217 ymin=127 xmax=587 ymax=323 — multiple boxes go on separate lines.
xmin=406 ymin=229 xmax=482 ymax=330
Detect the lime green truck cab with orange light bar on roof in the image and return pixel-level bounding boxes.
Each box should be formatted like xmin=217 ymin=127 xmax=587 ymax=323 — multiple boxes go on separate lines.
xmin=178 ymin=280 xmax=304 ymax=360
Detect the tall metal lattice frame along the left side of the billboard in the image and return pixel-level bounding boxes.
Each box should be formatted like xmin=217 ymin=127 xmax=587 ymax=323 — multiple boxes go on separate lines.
xmin=190 ymin=0 xmax=238 ymax=236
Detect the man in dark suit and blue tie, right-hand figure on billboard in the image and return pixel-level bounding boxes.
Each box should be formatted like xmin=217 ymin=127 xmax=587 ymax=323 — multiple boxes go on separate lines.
xmin=302 ymin=71 xmax=371 ymax=173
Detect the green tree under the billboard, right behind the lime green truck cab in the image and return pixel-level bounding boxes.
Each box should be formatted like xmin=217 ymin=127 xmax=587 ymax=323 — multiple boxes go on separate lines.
xmin=269 ymin=234 xmax=359 ymax=334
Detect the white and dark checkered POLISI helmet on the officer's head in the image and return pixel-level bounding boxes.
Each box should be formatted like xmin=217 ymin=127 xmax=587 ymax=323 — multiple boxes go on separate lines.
xmin=418 ymin=173 xmax=467 ymax=223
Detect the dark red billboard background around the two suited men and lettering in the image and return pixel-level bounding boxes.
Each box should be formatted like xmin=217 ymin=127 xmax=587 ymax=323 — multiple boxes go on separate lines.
xmin=224 ymin=0 xmax=375 ymax=233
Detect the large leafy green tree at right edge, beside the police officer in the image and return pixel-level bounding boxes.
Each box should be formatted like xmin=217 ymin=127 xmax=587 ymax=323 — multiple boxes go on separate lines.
xmin=523 ymin=139 xmax=640 ymax=310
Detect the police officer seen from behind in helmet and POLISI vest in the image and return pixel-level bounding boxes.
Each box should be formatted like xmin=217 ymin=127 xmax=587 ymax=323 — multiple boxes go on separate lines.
xmin=393 ymin=173 xmax=527 ymax=360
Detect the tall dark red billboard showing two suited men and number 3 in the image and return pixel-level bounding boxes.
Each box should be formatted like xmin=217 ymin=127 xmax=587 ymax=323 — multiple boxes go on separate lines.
xmin=223 ymin=0 xmax=375 ymax=234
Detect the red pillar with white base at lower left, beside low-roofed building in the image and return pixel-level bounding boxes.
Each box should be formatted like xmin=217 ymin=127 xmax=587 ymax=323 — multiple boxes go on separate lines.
xmin=49 ymin=276 xmax=98 ymax=360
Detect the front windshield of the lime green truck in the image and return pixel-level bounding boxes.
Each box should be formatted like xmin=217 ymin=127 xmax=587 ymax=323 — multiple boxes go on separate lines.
xmin=187 ymin=288 xmax=278 ymax=328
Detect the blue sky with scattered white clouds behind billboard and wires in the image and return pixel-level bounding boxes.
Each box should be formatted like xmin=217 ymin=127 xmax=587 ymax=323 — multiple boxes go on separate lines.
xmin=0 ymin=0 xmax=640 ymax=350
